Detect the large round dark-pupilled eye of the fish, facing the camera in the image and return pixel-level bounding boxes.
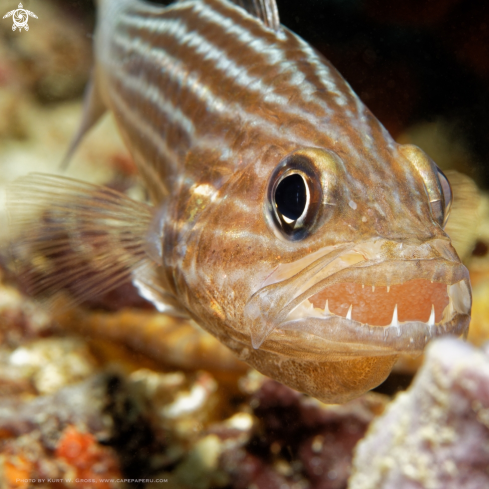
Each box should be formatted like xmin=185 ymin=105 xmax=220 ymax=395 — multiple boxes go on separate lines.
xmin=268 ymin=154 xmax=322 ymax=240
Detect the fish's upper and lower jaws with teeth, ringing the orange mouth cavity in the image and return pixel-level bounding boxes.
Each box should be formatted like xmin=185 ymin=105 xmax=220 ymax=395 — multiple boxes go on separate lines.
xmin=245 ymin=239 xmax=471 ymax=356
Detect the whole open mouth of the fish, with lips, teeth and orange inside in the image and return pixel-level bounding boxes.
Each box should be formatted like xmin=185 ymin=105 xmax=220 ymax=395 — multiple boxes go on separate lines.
xmin=247 ymin=240 xmax=471 ymax=354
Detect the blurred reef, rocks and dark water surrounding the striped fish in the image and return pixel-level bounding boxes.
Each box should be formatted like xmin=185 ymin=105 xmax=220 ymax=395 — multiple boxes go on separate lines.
xmin=0 ymin=0 xmax=489 ymax=489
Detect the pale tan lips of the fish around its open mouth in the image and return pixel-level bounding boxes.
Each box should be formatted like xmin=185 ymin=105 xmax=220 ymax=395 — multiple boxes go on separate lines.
xmin=245 ymin=236 xmax=471 ymax=350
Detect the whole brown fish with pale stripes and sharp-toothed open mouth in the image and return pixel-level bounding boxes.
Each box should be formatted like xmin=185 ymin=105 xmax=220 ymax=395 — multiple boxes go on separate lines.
xmin=6 ymin=0 xmax=471 ymax=402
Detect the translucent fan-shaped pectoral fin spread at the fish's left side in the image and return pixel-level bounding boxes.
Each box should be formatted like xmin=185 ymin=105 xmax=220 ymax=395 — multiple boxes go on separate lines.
xmin=7 ymin=173 xmax=179 ymax=308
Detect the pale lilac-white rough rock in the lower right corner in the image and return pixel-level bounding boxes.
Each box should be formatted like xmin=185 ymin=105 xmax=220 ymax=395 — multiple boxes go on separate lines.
xmin=348 ymin=338 xmax=489 ymax=489
